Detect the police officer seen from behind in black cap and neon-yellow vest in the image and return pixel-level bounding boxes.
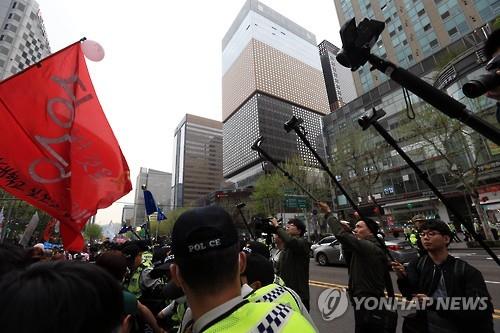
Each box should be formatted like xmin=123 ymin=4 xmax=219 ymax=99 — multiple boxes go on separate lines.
xmin=170 ymin=206 xmax=315 ymax=332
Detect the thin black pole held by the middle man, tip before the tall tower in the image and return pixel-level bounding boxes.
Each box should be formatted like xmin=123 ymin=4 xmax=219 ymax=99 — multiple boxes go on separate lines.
xmin=284 ymin=116 xmax=395 ymax=261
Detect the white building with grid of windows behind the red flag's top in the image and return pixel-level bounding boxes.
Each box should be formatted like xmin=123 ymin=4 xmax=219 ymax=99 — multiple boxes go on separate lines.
xmin=0 ymin=0 xmax=50 ymax=80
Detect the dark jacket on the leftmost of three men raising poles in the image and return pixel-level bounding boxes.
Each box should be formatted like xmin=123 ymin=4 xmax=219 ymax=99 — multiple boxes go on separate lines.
xmin=276 ymin=227 xmax=310 ymax=307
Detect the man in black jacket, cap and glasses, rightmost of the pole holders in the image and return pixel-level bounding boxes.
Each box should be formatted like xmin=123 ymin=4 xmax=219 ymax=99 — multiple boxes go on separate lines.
xmin=392 ymin=220 xmax=493 ymax=333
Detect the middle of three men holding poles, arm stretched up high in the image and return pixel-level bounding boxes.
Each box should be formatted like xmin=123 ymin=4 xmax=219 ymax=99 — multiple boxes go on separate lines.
xmin=318 ymin=202 xmax=388 ymax=333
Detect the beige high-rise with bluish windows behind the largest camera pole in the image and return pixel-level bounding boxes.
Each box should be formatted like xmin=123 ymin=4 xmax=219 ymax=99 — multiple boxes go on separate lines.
xmin=334 ymin=0 xmax=500 ymax=95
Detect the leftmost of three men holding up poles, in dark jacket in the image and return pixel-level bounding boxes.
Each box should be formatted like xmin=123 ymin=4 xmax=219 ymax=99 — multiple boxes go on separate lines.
xmin=271 ymin=218 xmax=310 ymax=311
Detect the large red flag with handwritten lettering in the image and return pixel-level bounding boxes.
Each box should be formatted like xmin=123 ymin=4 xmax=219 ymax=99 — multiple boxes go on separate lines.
xmin=0 ymin=42 xmax=132 ymax=251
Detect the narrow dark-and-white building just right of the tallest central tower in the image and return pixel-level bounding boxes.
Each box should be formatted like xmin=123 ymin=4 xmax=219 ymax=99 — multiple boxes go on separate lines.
xmin=318 ymin=40 xmax=357 ymax=111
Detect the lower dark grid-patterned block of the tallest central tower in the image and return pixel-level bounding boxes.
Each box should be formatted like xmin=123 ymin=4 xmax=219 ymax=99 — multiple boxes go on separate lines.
xmin=224 ymin=93 xmax=324 ymax=178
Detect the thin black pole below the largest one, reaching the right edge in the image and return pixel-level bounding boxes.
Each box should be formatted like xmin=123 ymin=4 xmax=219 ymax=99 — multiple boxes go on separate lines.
xmin=358 ymin=108 xmax=500 ymax=266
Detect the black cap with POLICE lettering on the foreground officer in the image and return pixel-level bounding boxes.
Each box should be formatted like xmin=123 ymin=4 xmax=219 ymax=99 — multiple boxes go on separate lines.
xmin=172 ymin=206 xmax=238 ymax=258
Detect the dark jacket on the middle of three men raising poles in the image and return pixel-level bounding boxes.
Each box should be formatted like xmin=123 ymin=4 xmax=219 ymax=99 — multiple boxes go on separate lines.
xmin=326 ymin=215 xmax=388 ymax=297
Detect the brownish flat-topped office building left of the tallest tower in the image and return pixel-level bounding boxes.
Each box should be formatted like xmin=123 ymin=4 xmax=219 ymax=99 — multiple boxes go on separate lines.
xmin=171 ymin=114 xmax=223 ymax=208
